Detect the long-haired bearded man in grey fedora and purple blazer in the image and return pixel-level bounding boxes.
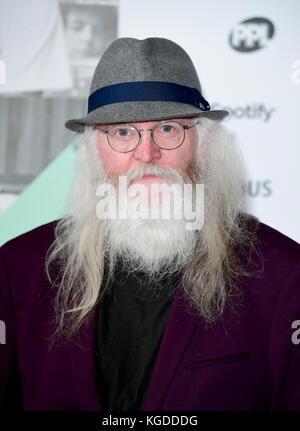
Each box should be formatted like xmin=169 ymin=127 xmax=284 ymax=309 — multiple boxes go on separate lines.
xmin=0 ymin=38 xmax=300 ymax=411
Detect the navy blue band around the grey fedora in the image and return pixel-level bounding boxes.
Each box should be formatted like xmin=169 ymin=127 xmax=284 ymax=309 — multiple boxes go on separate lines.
xmin=88 ymin=81 xmax=210 ymax=113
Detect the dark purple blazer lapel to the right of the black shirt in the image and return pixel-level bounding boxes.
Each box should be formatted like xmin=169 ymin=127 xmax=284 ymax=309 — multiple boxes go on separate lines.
xmin=142 ymin=283 xmax=199 ymax=411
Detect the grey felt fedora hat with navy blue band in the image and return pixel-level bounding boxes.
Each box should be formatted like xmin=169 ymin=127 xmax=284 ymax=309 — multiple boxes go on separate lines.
xmin=65 ymin=37 xmax=228 ymax=132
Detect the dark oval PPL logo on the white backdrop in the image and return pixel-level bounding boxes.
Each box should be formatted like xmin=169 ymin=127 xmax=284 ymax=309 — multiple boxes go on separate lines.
xmin=229 ymin=17 xmax=274 ymax=52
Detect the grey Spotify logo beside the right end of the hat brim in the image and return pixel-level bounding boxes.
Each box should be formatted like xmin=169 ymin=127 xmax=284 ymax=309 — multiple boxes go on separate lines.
xmin=211 ymin=103 xmax=276 ymax=123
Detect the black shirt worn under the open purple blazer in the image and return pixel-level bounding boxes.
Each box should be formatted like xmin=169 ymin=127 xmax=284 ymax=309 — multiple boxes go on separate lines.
xmin=95 ymin=263 xmax=180 ymax=411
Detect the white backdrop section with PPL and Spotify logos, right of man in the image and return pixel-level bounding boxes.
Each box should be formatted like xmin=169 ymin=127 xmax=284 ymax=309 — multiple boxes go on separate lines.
xmin=119 ymin=0 xmax=300 ymax=241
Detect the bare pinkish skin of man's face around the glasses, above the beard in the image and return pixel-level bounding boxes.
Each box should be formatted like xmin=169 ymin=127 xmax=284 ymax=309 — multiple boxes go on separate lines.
xmin=97 ymin=118 xmax=198 ymax=184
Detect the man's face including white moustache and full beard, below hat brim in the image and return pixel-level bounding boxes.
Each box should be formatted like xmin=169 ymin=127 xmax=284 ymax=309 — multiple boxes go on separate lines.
xmin=96 ymin=118 xmax=199 ymax=279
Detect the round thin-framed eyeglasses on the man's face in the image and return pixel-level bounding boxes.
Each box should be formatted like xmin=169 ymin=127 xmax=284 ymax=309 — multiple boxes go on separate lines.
xmin=94 ymin=120 xmax=199 ymax=153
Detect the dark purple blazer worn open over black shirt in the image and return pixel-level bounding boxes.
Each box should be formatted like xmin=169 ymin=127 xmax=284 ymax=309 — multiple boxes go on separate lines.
xmin=0 ymin=219 xmax=300 ymax=411
